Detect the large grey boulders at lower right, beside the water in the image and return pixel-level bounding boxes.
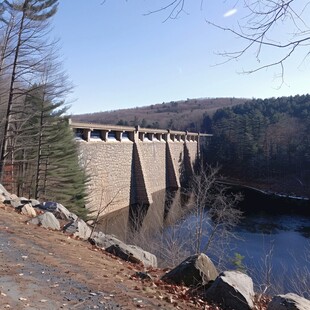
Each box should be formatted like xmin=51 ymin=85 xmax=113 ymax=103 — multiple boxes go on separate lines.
xmin=161 ymin=260 xmax=310 ymax=310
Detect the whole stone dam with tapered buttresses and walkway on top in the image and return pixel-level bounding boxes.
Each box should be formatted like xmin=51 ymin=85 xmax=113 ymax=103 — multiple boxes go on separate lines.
xmin=70 ymin=122 xmax=210 ymax=215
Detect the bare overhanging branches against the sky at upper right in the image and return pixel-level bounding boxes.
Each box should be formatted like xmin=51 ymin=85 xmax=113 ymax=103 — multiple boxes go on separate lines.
xmin=140 ymin=0 xmax=310 ymax=76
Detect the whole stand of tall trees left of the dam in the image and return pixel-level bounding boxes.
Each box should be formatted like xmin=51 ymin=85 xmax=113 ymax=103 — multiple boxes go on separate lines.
xmin=0 ymin=0 xmax=85 ymax=217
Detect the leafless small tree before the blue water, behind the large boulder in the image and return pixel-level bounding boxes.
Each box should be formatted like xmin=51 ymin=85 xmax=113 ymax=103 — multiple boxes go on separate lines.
xmin=190 ymin=166 xmax=242 ymax=264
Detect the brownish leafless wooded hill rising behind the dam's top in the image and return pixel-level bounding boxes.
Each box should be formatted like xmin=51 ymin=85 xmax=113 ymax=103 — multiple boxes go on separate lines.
xmin=72 ymin=98 xmax=248 ymax=131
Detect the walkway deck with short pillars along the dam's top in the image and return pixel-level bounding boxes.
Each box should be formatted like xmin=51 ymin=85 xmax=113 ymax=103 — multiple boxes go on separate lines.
xmin=70 ymin=121 xmax=212 ymax=143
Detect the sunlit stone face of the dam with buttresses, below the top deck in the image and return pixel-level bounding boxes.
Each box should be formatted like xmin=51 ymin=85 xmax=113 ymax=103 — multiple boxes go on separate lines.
xmin=78 ymin=133 xmax=198 ymax=215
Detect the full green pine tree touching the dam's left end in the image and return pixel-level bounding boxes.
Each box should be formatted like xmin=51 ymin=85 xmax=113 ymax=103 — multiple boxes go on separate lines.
xmin=38 ymin=111 xmax=87 ymax=216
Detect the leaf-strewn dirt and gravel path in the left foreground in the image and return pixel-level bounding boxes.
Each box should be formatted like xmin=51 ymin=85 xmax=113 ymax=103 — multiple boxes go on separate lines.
xmin=0 ymin=204 xmax=205 ymax=310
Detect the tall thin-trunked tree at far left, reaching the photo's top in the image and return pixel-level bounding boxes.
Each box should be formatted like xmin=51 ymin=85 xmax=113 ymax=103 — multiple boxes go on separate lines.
xmin=0 ymin=0 xmax=57 ymax=180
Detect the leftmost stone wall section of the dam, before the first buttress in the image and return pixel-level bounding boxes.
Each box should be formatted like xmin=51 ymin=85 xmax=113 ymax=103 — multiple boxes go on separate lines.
xmin=79 ymin=141 xmax=133 ymax=215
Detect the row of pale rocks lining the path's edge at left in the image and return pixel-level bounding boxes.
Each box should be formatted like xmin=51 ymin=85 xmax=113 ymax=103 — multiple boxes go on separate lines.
xmin=0 ymin=184 xmax=157 ymax=267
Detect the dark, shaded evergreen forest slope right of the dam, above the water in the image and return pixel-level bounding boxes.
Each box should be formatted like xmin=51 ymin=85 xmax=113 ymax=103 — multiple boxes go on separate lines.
xmin=201 ymin=95 xmax=310 ymax=196
